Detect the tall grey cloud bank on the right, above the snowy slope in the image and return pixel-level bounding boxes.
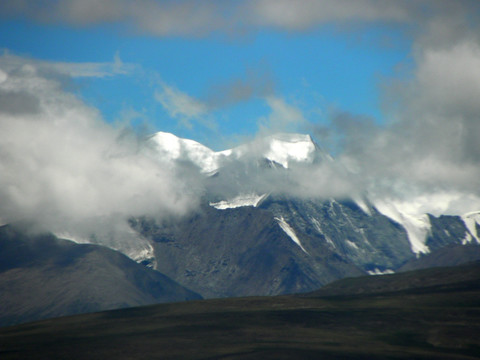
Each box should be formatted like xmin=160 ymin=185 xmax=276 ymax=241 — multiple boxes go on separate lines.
xmin=329 ymin=39 xmax=480 ymax=214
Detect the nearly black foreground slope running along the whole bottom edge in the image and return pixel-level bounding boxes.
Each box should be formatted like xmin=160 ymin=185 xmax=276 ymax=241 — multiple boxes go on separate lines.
xmin=0 ymin=262 xmax=480 ymax=359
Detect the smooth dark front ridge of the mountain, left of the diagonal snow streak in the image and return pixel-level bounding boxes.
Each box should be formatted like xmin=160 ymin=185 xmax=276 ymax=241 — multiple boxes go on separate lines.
xmin=132 ymin=206 xmax=363 ymax=297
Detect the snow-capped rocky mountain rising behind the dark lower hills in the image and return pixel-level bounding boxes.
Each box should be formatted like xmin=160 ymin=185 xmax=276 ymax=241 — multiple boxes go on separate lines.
xmin=129 ymin=133 xmax=480 ymax=298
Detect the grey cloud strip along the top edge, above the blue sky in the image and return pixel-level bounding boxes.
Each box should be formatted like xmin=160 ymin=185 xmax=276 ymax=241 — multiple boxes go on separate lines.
xmin=0 ymin=0 xmax=480 ymax=40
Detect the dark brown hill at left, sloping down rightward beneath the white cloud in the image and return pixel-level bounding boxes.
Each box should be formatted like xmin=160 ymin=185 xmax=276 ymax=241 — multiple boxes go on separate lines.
xmin=0 ymin=225 xmax=201 ymax=328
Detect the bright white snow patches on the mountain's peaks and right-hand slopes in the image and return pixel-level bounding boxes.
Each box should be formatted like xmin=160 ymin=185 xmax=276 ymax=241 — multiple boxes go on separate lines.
xmin=148 ymin=132 xmax=480 ymax=255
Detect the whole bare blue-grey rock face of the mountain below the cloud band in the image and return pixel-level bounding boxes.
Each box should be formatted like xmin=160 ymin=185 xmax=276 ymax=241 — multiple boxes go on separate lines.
xmin=131 ymin=196 xmax=480 ymax=298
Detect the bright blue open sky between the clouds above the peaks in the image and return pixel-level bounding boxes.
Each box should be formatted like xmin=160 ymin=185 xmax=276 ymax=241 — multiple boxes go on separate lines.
xmin=0 ymin=8 xmax=412 ymax=150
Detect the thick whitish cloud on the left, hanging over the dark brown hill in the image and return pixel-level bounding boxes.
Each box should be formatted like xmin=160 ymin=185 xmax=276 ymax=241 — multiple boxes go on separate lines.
xmin=0 ymin=55 xmax=198 ymax=243
